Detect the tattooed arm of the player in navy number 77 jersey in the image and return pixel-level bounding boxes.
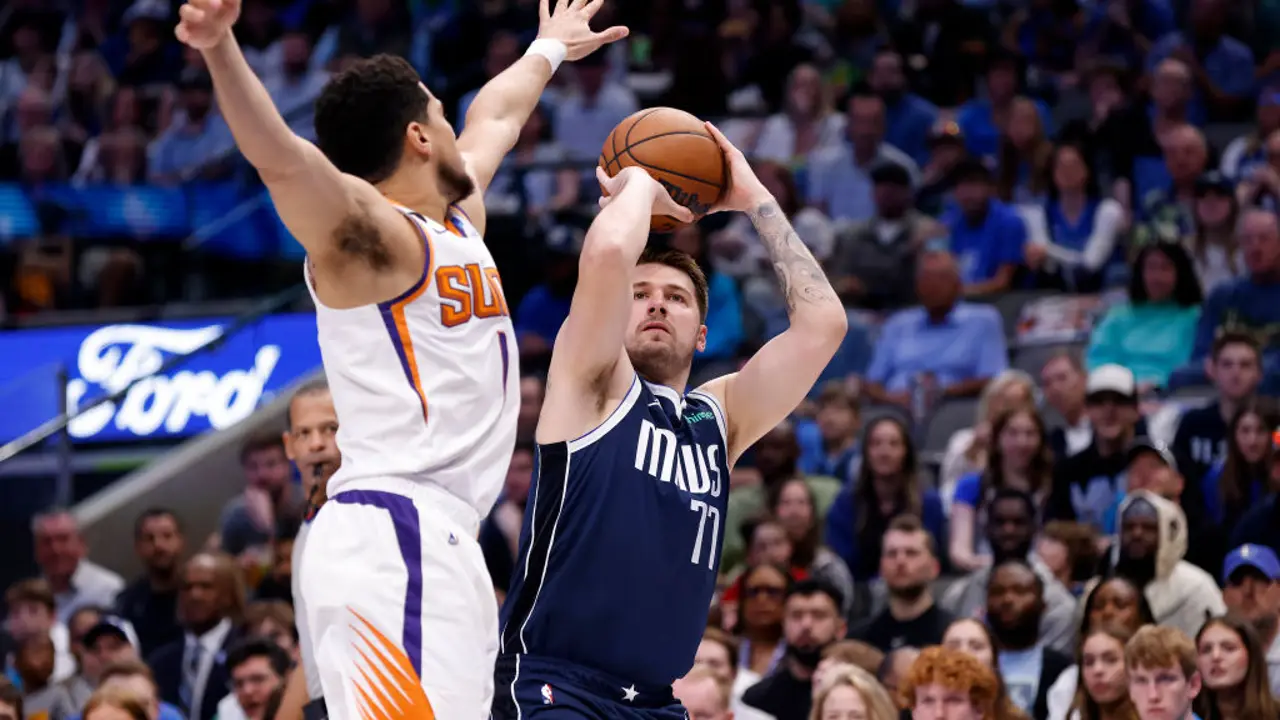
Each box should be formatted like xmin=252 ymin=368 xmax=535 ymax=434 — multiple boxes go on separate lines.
xmin=704 ymin=123 xmax=849 ymax=464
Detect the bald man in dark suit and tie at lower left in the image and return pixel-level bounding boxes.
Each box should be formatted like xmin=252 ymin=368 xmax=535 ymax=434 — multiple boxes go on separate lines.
xmin=147 ymin=552 xmax=244 ymax=720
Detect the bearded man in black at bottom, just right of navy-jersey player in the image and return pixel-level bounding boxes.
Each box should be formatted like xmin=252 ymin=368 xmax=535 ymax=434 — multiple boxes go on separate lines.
xmin=742 ymin=580 xmax=846 ymax=720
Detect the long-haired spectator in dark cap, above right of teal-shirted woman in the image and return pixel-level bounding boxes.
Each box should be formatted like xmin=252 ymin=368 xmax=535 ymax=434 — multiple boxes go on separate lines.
xmin=1189 ymin=170 xmax=1244 ymax=293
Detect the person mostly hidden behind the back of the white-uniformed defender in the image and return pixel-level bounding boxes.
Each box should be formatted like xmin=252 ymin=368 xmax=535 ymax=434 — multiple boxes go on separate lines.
xmin=275 ymin=379 xmax=342 ymax=720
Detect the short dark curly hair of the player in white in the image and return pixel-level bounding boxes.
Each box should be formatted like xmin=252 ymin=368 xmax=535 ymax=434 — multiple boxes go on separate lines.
xmin=315 ymin=54 xmax=428 ymax=183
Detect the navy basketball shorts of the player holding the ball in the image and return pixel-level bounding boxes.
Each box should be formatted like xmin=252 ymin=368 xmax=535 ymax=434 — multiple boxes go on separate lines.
xmin=493 ymin=655 xmax=689 ymax=720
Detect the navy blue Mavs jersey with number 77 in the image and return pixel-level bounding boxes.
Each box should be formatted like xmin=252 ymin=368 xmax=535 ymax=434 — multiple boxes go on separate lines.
xmin=500 ymin=377 xmax=728 ymax=687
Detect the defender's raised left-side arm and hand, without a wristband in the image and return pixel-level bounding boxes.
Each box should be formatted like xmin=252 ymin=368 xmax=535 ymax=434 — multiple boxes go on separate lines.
xmin=175 ymin=0 xmax=421 ymax=302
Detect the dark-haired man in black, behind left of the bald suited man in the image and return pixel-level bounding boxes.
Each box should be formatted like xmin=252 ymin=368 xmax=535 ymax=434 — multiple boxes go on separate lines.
xmin=116 ymin=507 xmax=187 ymax=655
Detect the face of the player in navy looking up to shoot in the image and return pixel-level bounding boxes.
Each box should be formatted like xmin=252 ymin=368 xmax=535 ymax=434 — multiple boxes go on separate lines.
xmin=626 ymin=264 xmax=707 ymax=382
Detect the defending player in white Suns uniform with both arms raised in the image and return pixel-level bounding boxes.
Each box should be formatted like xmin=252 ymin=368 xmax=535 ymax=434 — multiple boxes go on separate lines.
xmin=177 ymin=0 xmax=626 ymax=720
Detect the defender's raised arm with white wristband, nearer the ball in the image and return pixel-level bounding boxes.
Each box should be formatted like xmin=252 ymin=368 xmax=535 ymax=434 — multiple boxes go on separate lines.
xmin=458 ymin=0 xmax=627 ymax=210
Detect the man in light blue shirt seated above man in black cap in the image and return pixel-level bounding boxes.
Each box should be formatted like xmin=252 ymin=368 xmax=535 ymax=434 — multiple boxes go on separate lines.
xmin=805 ymin=86 xmax=919 ymax=222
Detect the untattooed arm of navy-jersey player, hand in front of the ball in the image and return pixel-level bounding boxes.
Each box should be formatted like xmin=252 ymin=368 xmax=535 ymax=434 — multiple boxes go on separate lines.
xmin=538 ymin=168 xmax=692 ymax=443
